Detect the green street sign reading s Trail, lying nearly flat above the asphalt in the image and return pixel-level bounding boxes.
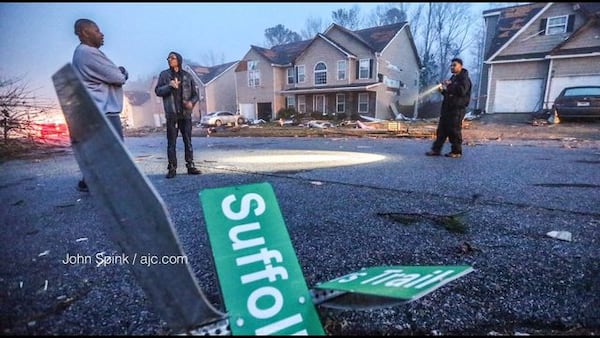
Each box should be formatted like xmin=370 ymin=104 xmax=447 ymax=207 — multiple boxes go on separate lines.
xmin=316 ymin=265 xmax=473 ymax=301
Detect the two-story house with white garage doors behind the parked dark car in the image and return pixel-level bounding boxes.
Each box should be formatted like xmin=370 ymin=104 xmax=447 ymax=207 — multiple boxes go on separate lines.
xmin=477 ymin=2 xmax=600 ymax=113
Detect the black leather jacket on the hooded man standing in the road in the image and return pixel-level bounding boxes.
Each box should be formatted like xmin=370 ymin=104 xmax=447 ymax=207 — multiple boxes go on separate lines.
xmin=154 ymin=55 xmax=198 ymax=119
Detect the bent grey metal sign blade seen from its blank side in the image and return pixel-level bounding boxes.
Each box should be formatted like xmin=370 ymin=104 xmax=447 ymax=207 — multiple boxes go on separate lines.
xmin=52 ymin=64 xmax=225 ymax=332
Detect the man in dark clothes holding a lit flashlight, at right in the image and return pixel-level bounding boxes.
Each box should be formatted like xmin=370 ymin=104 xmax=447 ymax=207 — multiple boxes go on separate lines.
xmin=426 ymin=58 xmax=472 ymax=158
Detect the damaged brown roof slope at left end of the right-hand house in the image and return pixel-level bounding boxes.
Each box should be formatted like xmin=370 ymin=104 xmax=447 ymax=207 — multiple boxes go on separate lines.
xmin=483 ymin=2 xmax=548 ymax=60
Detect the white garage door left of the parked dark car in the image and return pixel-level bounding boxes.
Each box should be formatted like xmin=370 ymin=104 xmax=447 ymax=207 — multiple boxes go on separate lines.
xmin=494 ymin=79 xmax=544 ymax=113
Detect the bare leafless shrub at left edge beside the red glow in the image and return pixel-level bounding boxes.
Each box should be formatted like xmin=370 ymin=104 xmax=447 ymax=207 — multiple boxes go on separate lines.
xmin=0 ymin=77 xmax=52 ymax=143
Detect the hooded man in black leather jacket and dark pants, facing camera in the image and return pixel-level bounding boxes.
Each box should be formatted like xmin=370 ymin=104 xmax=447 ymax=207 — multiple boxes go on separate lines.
xmin=154 ymin=52 xmax=200 ymax=178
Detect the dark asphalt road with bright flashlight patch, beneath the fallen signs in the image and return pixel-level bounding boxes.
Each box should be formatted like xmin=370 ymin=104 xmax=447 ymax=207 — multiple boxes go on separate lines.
xmin=0 ymin=134 xmax=600 ymax=335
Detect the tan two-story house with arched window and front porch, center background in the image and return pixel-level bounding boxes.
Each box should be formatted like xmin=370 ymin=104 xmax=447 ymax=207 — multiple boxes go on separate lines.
xmin=235 ymin=22 xmax=420 ymax=120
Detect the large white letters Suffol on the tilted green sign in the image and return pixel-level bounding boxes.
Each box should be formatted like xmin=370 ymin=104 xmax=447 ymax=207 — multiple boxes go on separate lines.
xmin=221 ymin=193 xmax=308 ymax=335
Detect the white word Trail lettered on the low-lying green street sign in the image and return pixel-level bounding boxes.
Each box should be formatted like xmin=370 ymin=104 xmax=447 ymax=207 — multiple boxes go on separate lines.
xmin=354 ymin=269 xmax=454 ymax=289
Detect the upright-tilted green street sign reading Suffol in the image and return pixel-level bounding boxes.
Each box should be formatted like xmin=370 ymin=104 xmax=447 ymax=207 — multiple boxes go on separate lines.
xmin=200 ymin=183 xmax=325 ymax=335
